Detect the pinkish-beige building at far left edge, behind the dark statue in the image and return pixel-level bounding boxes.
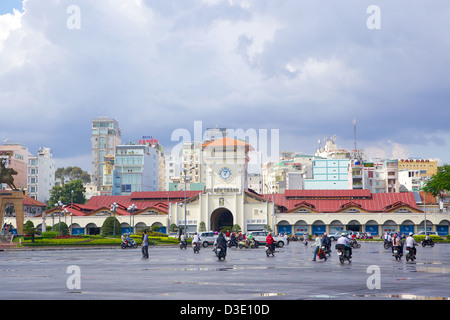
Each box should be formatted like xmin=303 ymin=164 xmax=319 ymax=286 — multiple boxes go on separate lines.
xmin=0 ymin=142 xmax=33 ymax=189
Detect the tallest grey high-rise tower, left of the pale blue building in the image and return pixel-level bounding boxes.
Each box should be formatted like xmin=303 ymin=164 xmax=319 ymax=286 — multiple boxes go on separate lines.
xmin=91 ymin=117 xmax=122 ymax=190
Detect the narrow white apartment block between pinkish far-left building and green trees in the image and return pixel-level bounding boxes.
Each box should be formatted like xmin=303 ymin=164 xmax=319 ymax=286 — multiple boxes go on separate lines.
xmin=27 ymin=148 xmax=56 ymax=203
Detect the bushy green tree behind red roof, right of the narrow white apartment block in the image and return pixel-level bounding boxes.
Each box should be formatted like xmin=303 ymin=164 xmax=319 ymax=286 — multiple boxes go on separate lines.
xmin=48 ymin=179 xmax=86 ymax=209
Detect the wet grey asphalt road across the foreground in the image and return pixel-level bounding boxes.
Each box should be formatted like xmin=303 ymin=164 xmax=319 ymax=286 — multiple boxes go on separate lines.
xmin=0 ymin=242 xmax=450 ymax=300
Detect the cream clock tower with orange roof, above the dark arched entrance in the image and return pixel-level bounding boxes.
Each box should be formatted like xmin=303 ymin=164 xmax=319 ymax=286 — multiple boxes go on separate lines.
xmin=202 ymin=137 xmax=253 ymax=193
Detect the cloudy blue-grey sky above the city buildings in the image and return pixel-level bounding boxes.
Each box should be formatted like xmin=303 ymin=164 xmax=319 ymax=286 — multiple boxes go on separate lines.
xmin=0 ymin=0 xmax=450 ymax=171
